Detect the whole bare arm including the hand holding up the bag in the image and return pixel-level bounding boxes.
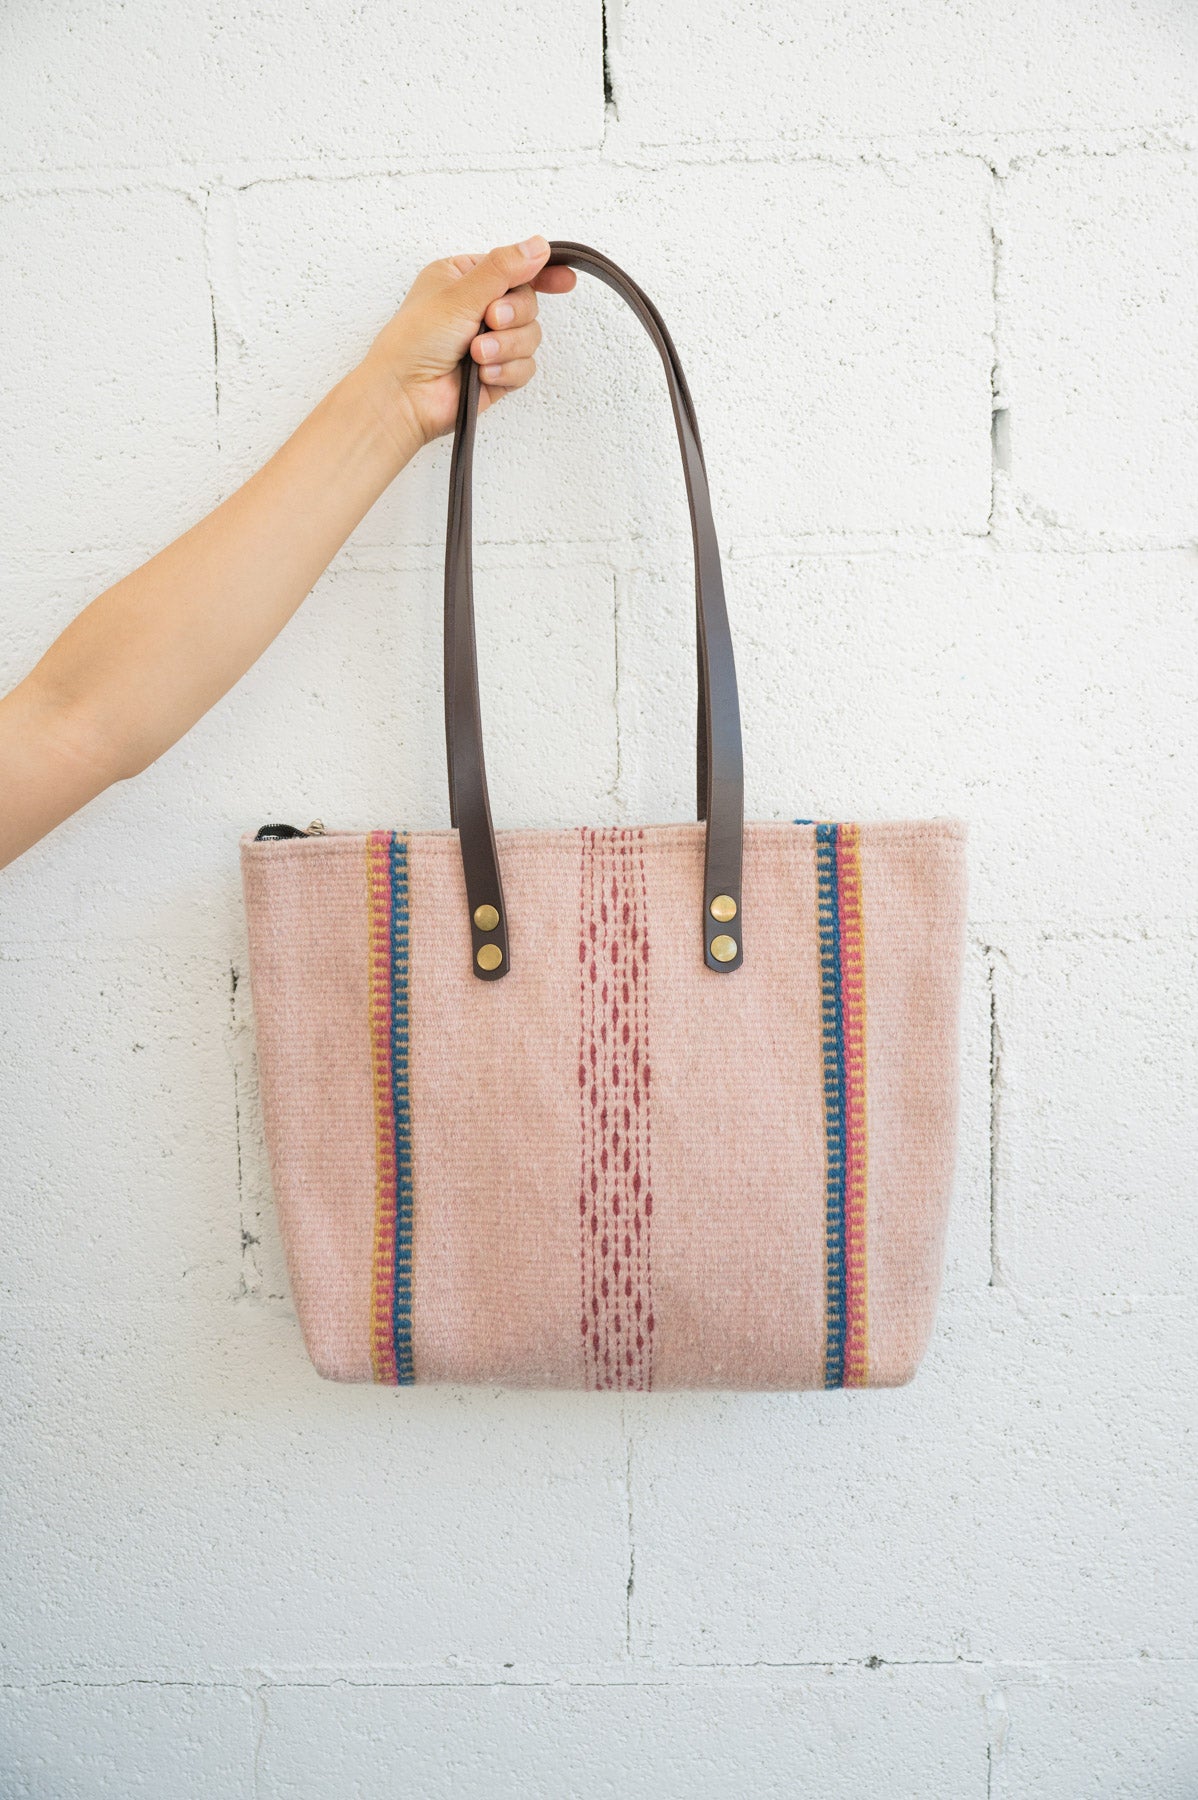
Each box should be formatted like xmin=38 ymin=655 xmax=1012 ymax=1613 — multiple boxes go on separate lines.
xmin=0 ymin=238 xmax=574 ymax=868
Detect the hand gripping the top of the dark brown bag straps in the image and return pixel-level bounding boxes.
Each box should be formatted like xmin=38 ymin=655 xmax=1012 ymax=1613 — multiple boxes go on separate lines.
xmin=363 ymin=238 xmax=577 ymax=448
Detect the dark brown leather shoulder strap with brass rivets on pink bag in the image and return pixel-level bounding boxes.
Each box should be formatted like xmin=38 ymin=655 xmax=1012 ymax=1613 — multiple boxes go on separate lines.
xmin=444 ymin=241 xmax=745 ymax=981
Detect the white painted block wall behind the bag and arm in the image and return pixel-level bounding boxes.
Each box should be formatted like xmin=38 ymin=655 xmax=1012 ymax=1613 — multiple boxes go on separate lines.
xmin=0 ymin=0 xmax=1198 ymax=1800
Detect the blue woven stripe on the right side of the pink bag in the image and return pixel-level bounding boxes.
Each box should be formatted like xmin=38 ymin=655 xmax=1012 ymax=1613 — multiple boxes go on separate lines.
xmin=795 ymin=821 xmax=849 ymax=1388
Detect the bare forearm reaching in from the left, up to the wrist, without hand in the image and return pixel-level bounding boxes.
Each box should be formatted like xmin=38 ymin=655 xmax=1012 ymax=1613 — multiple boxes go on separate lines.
xmin=0 ymin=365 xmax=419 ymax=864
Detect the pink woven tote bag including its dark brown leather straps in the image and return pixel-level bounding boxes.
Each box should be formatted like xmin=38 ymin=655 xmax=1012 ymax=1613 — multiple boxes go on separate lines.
xmin=241 ymin=243 xmax=964 ymax=1390
